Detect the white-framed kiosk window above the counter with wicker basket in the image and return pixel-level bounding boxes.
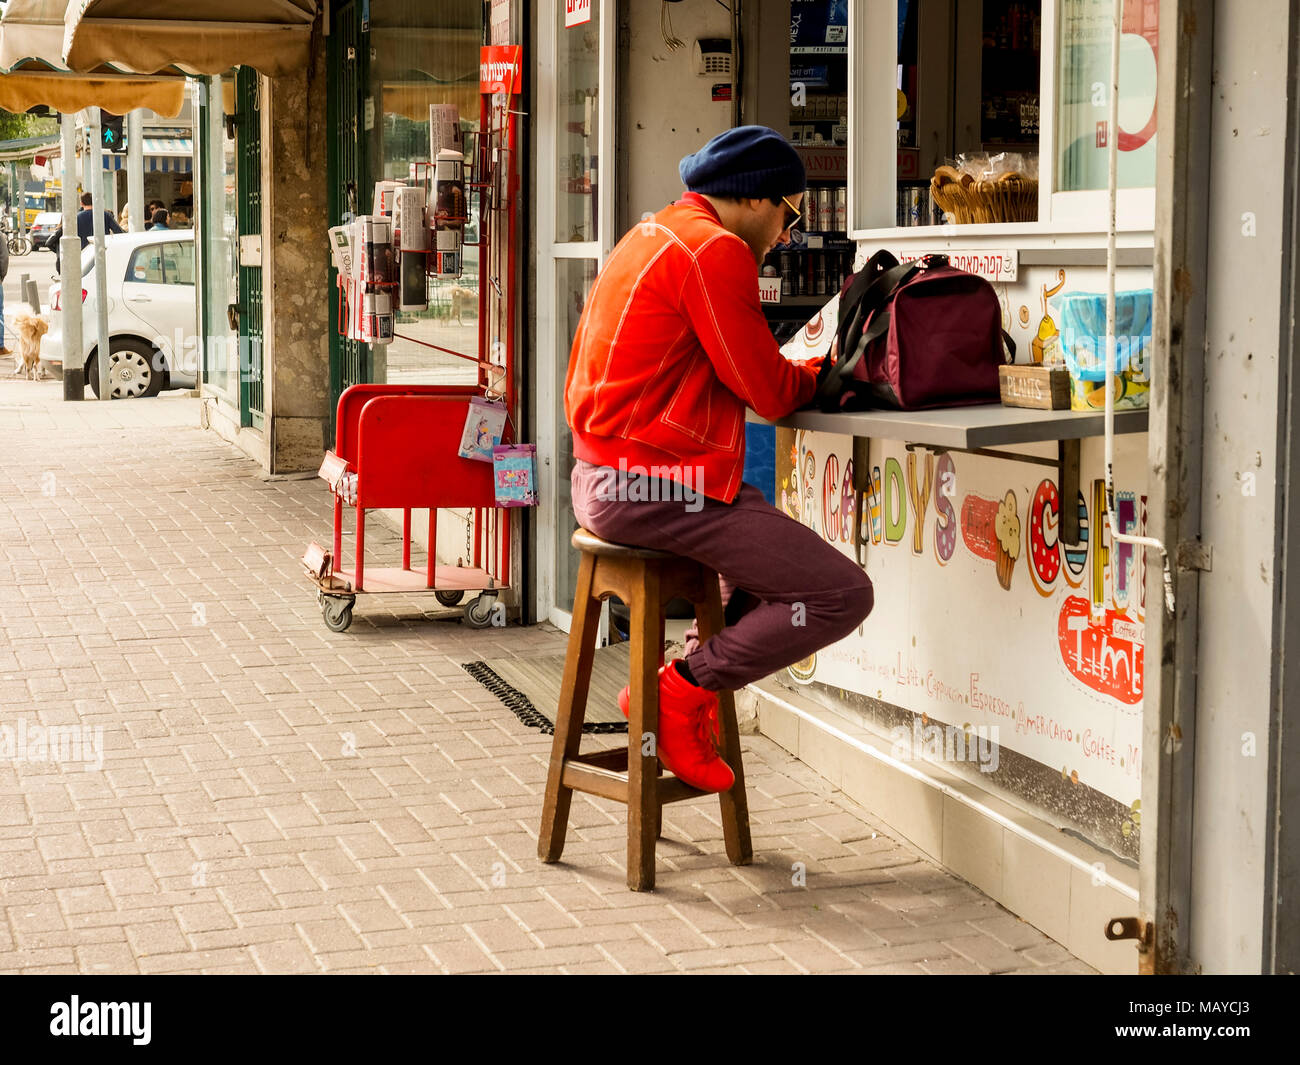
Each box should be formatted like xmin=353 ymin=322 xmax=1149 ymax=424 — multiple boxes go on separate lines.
xmin=848 ymin=0 xmax=1158 ymax=238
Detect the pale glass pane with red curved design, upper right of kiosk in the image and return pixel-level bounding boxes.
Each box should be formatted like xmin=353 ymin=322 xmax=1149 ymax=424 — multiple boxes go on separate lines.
xmin=1054 ymin=0 xmax=1160 ymax=192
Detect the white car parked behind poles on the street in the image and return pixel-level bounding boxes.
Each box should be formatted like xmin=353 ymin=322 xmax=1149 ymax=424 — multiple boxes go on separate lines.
xmin=42 ymin=229 xmax=202 ymax=399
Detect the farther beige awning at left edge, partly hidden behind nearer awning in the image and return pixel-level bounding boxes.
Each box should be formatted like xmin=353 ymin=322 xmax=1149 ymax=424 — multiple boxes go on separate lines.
xmin=0 ymin=0 xmax=185 ymax=118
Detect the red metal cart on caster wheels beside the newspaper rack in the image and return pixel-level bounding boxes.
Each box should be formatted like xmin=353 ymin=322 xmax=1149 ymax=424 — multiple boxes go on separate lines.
xmin=303 ymin=385 xmax=510 ymax=632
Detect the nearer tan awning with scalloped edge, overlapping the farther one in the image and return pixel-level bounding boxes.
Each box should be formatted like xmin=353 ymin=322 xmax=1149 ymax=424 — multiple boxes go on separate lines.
xmin=61 ymin=0 xmax=317 ymax=77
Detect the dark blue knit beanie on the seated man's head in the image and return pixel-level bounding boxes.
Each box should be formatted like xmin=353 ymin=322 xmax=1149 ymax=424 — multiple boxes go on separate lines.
xmin=677 ymin=126 xmax=806 ymax=199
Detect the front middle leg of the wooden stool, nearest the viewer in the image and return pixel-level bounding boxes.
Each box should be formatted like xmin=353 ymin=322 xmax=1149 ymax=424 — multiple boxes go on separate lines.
xmin=628 ymin=562 xmax=662 ymax=891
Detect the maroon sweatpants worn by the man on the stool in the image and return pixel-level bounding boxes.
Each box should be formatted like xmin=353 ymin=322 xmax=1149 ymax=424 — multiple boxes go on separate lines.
xmin=572 ymin=459 xmax=874 ymax=692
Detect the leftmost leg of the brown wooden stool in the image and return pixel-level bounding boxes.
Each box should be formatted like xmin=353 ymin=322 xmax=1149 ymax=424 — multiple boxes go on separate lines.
xmin=537 ymin=554 xmax=601 ymax=862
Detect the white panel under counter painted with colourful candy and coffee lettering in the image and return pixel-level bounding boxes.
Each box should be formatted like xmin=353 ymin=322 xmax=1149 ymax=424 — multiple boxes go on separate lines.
xmin=776 ymin=429 xmax=1147 ymax=806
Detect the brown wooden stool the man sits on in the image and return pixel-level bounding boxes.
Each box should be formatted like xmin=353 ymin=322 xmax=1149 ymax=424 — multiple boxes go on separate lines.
xmin=537 ymin=529 xmax=754 ymax=891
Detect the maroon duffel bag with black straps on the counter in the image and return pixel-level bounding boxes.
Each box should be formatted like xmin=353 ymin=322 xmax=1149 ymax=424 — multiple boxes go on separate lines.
xmin=813 ymin=251 xmax=1015 ymax=411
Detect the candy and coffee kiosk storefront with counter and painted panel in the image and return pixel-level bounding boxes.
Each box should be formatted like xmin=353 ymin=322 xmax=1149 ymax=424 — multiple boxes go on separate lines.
xmin=536 ymin=0 xmax=1160 ymax=971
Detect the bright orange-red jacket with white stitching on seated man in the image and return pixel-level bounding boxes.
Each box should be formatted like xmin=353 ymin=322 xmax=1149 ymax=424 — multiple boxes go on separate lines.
xmin=564 ymin=192 xmax=816 ymax=503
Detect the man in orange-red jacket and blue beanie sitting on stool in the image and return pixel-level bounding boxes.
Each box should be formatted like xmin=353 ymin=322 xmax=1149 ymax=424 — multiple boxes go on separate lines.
xmin=564 ymin=126 xmax=874 ymax=792
